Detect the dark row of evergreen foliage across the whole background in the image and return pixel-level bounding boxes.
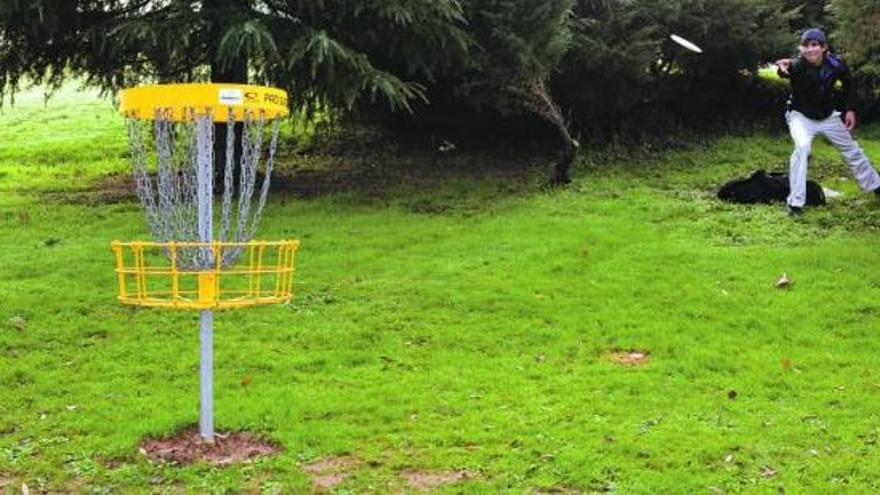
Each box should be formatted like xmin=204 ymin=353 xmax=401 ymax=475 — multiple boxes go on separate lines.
xmin=0 ymin=0 xmax=880 ymax=148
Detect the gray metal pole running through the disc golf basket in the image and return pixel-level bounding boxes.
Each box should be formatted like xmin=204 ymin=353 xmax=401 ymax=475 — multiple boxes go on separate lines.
xmin=196 ymin=115 xmax=214 ymax=443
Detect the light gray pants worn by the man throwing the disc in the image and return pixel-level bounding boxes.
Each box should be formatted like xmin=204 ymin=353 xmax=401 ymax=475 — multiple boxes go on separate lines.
xmin=785 ymin=110 xmax=880 ymax=207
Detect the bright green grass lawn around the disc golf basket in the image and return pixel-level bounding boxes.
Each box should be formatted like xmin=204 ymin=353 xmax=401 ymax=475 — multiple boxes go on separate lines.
xmin=0 ymin=83 xmax=880 ymax=493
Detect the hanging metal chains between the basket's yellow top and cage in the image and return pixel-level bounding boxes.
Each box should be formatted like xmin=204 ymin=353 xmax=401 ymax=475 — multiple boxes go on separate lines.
xmin=127 ymin=103 xmax=281 ymax=270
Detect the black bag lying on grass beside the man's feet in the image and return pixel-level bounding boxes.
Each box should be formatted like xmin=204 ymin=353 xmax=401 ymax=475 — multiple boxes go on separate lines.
xmin=718 ymin=170 xmax=825 ymax=206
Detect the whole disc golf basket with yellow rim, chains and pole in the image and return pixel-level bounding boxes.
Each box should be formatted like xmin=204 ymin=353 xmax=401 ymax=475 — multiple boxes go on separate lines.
xmin=111 ymin=84 xmax=299 ymax=443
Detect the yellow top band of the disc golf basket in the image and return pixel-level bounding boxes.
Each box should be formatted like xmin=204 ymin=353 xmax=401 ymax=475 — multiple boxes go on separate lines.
xmin=119 ymin=83 xmax=290 ymax=122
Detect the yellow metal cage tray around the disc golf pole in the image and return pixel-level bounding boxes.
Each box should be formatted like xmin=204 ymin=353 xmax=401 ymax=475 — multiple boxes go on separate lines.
xmin=110 ymin=240 xmax=299 ymax=310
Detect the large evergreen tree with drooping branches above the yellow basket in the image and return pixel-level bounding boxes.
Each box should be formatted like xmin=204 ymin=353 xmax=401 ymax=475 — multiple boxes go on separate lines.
xmin=0 ymin=0 xmax=467 ymax=108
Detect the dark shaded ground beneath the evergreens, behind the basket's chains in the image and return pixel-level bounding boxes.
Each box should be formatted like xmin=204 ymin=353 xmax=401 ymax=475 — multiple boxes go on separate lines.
xmin=39 ymin=148 xmax=552 ymax=214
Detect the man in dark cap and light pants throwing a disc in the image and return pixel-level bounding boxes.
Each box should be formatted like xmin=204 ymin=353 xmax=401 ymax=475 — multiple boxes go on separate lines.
xmin=776 ymin=29 xmax=880 ymax=216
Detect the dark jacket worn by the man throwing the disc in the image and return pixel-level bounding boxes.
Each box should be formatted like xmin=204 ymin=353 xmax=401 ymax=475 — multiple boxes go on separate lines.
xmin=779 ymin=53 xmax=855 ymax=120
